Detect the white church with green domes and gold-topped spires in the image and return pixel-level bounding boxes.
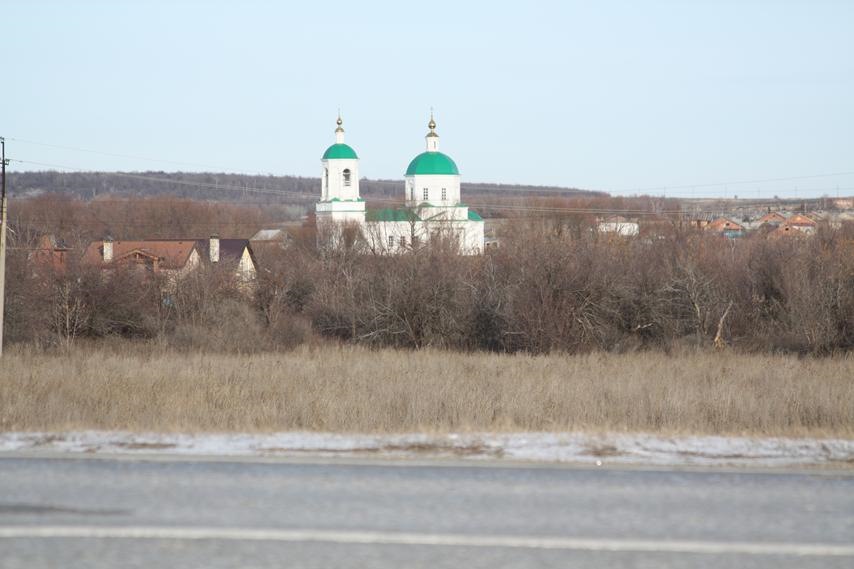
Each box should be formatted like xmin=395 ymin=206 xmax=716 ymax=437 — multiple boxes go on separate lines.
xmin=315 ymin=115 xmax=484 ymax=255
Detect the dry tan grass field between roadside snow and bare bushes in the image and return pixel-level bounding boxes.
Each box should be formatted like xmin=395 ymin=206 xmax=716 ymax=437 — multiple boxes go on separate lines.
xmin=0 ymin=346 xmax=854 ymax=438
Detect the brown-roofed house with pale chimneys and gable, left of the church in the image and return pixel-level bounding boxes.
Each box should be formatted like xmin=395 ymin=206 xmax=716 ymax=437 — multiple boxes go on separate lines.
xmin=83 ymin=235 xmax=257 ymax=282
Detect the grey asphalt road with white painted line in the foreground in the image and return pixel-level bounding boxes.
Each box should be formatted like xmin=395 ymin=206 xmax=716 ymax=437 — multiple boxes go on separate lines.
xmin=0 ymin=457 xmax=854 ymax=569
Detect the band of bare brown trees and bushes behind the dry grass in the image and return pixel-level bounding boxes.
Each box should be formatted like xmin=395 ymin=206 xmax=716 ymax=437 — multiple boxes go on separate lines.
xmin=6 ymin=204 xmax=854 ymax=354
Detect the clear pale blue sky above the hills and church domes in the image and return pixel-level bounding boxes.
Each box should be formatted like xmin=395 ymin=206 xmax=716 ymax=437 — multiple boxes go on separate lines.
xmin=0 ymin=0 xmax=854 ymax=198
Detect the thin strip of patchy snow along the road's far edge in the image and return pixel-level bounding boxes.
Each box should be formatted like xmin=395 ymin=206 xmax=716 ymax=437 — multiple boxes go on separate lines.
xmin=0 ymin=431 xmax=854 ymax=467
